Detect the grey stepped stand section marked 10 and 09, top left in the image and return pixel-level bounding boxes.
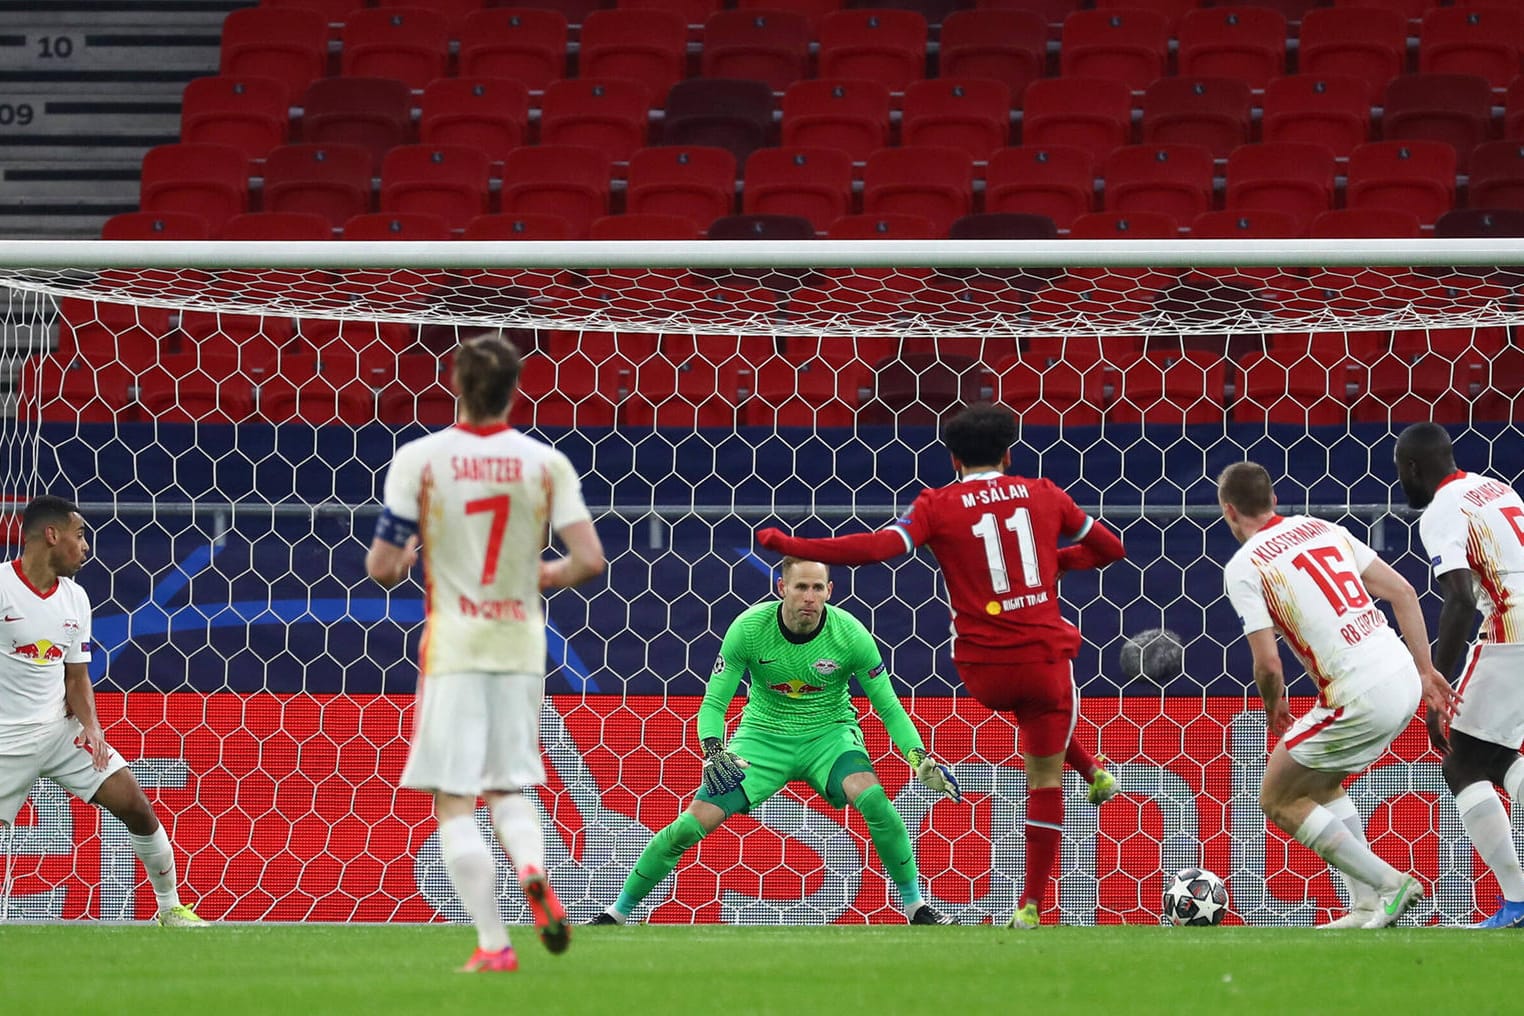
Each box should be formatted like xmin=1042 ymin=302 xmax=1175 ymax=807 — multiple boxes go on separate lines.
xmin=0 ymin=0 xmax=240 ymax=239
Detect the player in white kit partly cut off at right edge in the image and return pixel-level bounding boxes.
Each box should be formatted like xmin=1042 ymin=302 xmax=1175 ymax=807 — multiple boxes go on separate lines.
xmin=1396 ymin=423 xmax=1524 ymax=928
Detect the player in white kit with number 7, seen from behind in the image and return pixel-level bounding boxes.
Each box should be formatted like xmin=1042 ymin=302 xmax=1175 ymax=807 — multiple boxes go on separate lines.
xmin=366 ymin=332 xmax=604 ymax=972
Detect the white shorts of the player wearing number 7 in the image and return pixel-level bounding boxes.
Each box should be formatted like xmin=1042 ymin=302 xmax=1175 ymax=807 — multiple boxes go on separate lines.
xmin=402 ymin=673 xmax=546 ymax=797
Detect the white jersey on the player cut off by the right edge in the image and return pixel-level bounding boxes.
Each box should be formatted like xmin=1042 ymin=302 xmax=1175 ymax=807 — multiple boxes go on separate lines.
xmin=1419 ymin=472 xmax=1524 ymax=643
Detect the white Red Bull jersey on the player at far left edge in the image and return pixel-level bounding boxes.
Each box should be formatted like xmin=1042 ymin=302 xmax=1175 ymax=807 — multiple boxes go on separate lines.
xmin=0 ymin=561 xmax=90 ymax=724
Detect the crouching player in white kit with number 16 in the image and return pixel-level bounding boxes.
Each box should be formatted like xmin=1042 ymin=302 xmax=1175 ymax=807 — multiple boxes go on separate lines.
xmin=1218 ymin=462 xmax=1454 ymax=928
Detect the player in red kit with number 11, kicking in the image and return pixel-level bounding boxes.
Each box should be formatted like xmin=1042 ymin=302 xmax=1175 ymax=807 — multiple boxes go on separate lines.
xmin=757 ymin=404 xmax=1125 ymax=929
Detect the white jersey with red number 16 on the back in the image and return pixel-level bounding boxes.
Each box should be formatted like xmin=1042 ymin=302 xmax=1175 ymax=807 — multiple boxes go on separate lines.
xmin=1225 ymin=515 xmax=1413 ymax=708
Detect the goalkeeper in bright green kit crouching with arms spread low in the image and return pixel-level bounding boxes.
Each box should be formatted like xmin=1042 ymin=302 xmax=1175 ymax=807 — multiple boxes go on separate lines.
xmin=591 ymin=558 xmax=962 ymax=925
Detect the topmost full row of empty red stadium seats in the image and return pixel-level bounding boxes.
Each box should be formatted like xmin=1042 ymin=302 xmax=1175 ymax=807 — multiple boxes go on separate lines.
xmin=223 ymin=3 xmax=1524 ymax=102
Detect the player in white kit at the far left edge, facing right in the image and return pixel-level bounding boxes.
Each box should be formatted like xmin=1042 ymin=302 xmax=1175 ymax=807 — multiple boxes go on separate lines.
xmin=0 ymin=497 xmax=206 ymax=928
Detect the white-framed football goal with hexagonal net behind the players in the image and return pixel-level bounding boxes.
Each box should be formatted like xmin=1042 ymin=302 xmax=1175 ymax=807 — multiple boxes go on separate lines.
xmin=0 ymin=239 xmax=1524 ymax=925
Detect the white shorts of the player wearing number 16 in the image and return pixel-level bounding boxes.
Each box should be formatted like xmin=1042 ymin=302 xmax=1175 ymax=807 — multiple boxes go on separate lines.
xmin=1280 ymin=661 xmax=1423 ymax=772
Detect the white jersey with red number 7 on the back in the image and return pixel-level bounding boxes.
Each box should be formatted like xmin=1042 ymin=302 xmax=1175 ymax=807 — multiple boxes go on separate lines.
xmin=384 ymin=425 xmax=591 ymax=675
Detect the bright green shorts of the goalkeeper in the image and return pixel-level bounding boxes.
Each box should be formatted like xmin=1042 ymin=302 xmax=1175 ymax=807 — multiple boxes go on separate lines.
xmin=696 ymin=722 xmax=873 ymax=816
